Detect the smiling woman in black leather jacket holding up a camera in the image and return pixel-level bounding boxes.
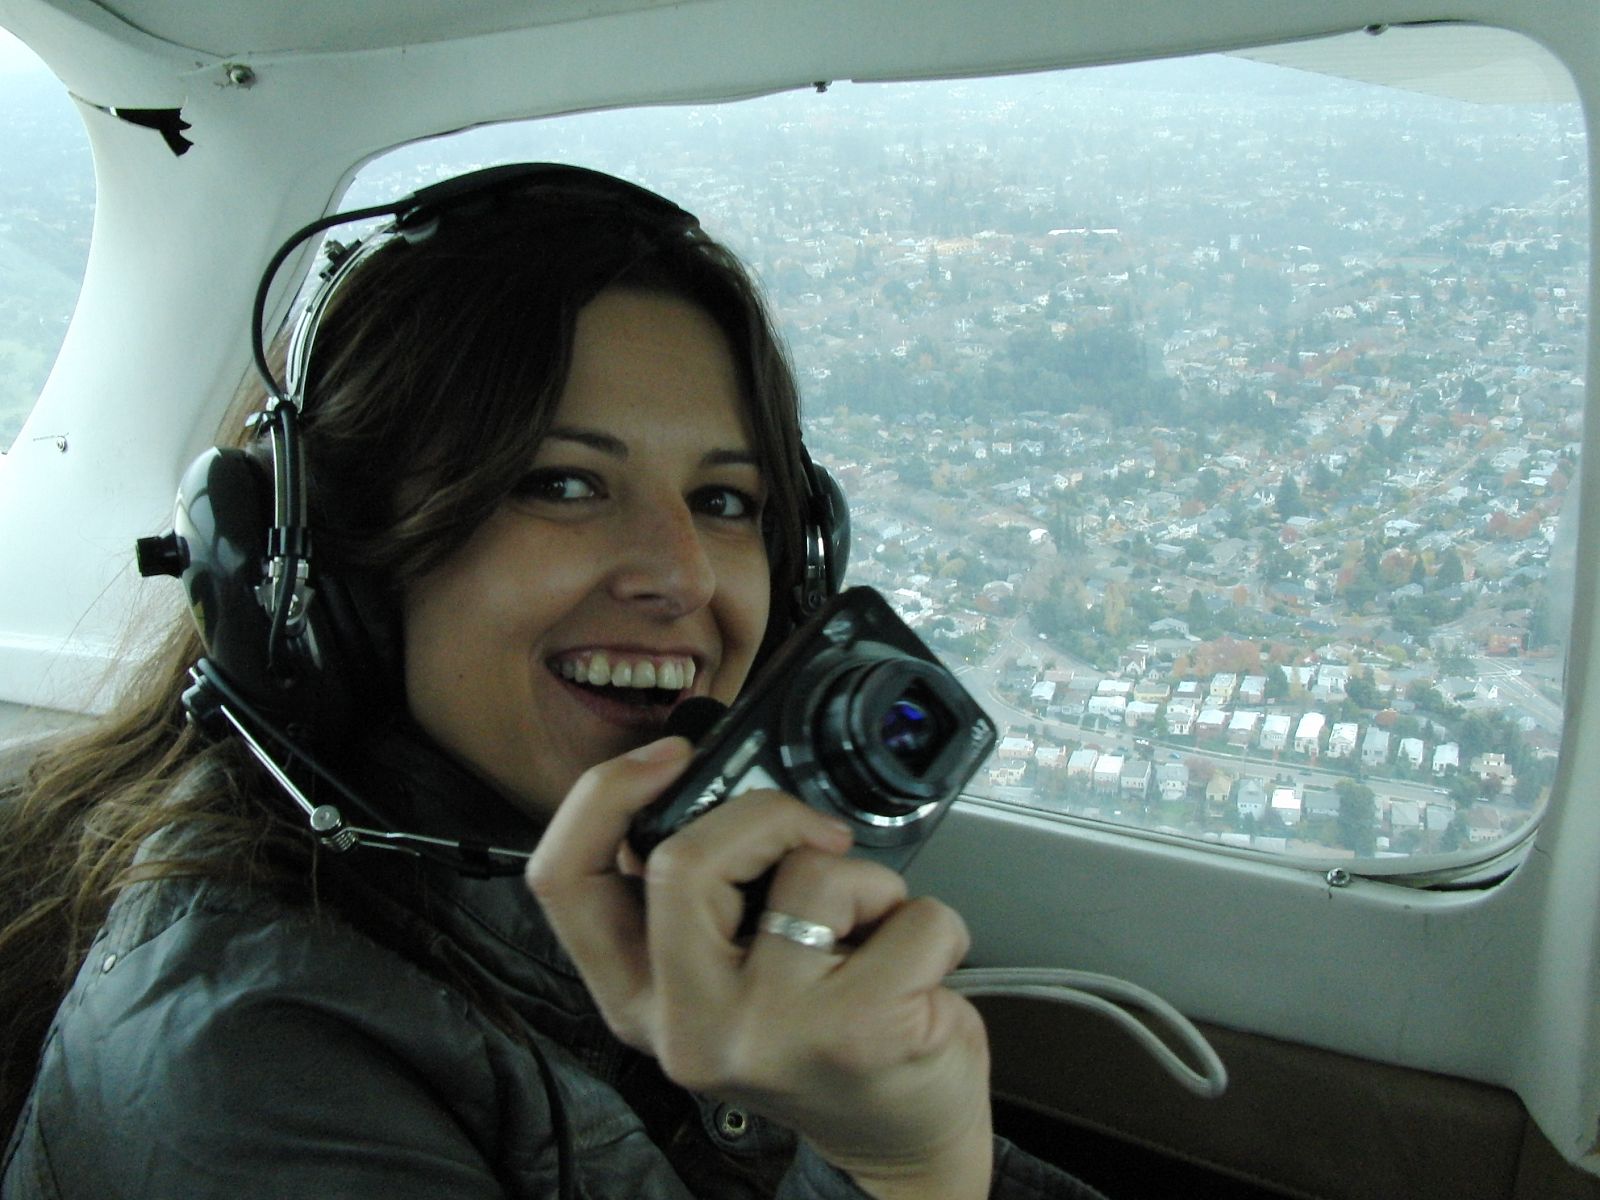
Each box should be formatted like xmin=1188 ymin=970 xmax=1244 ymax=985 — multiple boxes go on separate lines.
xmin=0 ymin=168 xmax=1090 ymax=1200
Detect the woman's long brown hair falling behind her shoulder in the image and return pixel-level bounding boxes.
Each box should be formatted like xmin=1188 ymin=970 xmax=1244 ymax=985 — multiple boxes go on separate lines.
xmin=0 ymin=167 xmax=806 ymax=1130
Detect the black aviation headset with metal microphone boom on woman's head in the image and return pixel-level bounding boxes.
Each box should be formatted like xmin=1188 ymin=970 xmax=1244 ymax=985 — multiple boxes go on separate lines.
xmin=138 ymin=163 xmax=850 ymax=874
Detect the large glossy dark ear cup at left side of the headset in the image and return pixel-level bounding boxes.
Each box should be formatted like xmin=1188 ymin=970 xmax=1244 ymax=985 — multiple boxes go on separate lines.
xmin=173 ymin=450 xmax=398 ymax=744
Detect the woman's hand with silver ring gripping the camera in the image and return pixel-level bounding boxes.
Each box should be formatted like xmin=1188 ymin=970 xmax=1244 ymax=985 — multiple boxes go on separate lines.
xmin=528 ymin=739 xmax=992 ymax=1200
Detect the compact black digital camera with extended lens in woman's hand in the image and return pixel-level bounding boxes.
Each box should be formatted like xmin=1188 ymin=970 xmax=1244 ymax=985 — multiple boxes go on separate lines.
xmin=629 ymin=587 xmax=995 ymax=870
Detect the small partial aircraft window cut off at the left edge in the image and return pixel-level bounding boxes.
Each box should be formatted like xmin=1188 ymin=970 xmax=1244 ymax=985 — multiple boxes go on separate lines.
xmin=0 ymin=29 xmax=94 ymax=451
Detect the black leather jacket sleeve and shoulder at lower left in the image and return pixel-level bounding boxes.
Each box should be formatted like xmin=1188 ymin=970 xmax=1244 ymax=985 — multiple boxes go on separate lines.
xmin=6 ymin=912 xmax=557 ymax=1200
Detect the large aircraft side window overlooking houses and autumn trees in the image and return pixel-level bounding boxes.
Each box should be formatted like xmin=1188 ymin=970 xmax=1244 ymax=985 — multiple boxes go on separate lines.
xmin=350 ymin=30 xmax=1589 ymax=870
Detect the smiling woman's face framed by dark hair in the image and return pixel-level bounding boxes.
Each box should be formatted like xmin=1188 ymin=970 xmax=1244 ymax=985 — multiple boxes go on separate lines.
xmin=403 ymin=288 xmax=770 ymax=818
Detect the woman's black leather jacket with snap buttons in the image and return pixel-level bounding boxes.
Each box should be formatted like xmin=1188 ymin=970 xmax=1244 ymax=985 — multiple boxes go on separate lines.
xmin=0 ymin=739 xmax=1094 ymax=1200
